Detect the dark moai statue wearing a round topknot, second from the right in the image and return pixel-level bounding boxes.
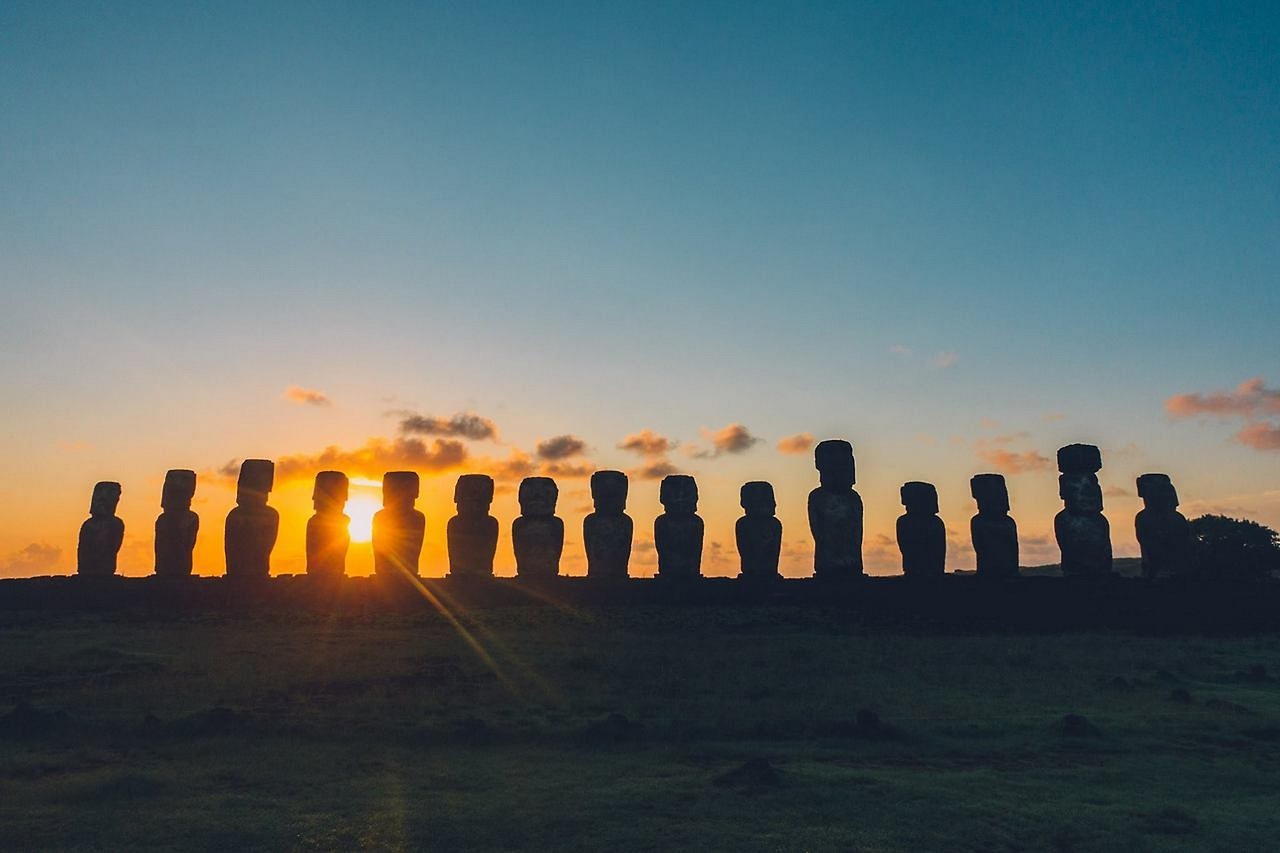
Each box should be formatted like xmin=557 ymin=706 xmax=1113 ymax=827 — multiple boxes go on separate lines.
xmin=1053 ymin=444 xmax=1111 ymax=576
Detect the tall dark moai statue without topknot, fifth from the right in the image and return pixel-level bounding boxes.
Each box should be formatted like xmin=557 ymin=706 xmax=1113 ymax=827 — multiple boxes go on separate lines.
xmin=809 ymin=439 xmax=863 ymax=580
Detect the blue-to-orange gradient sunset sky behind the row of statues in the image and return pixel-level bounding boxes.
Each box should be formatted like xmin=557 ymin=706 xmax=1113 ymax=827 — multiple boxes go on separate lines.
xmin=0 ymin=0 xmax=1280 ymax=575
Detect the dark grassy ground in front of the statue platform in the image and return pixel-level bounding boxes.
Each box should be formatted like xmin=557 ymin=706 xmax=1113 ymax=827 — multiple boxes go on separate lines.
xmin=0 ymin=607 xmax=1280 ymax=852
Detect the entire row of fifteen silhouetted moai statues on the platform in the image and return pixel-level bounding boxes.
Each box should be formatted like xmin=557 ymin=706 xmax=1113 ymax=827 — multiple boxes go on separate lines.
xmin=78 ymin=439 xmax=1190 ymax=580
